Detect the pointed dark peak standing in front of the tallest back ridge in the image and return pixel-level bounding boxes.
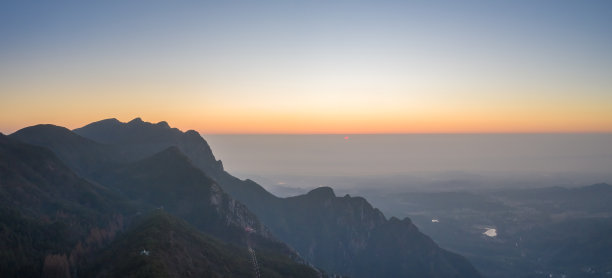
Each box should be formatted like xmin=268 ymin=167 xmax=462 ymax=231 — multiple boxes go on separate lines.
xmin=93 ymin=147 xmax=280 ymax=249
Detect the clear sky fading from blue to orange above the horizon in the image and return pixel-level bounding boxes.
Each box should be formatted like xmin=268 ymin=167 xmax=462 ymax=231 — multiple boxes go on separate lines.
xmin=0 ymin=0 xmax=612 ymax=133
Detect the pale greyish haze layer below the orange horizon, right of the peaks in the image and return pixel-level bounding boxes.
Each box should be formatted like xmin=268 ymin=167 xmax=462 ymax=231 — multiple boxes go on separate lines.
xmin=204 ymin=134 xmax=612 ymax=195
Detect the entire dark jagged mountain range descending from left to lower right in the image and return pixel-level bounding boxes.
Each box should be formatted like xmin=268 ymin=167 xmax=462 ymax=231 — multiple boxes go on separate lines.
xmin=0 ymin=118 xmax=480 ymax=278
